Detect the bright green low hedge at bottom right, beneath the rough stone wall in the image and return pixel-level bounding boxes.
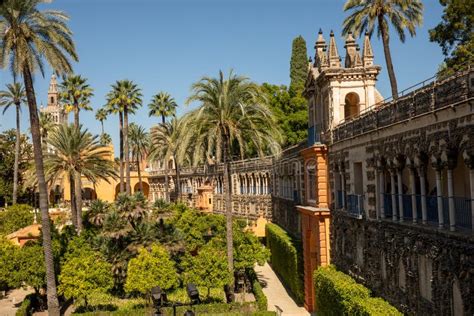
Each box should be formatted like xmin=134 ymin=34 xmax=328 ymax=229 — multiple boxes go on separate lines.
xmin=314 ymin=266 xmax=402 ymax=316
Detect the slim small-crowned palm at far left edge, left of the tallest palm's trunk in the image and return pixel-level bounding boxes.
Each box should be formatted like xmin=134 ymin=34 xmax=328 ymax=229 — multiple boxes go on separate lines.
xmin=0 ymin=82 xmax=26 ymax=204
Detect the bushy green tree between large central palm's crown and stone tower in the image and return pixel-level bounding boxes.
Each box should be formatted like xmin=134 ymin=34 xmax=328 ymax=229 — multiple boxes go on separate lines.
xmin=262 ymin=83 xmax=308 ymax=147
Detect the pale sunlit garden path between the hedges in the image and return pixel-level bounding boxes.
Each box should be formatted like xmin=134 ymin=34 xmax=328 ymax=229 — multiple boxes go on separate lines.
xmin=255 ymin=262 xmax=310 ymax=316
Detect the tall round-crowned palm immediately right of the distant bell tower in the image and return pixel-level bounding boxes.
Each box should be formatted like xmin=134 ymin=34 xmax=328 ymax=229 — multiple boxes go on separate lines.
xmin=59 ymin=74 xmax=94 ymax=218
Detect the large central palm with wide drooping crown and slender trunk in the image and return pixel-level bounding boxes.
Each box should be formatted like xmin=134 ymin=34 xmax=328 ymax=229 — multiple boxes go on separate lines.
xmin=186 ymin=71 xmax=281 ymax=296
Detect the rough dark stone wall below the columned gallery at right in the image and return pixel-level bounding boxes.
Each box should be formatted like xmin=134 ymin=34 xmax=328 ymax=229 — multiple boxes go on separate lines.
xmin=331 ymin=211 xmax=474 ymax=315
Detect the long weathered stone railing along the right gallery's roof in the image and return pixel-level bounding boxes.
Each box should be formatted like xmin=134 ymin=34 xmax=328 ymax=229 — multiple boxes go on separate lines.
xmin=332 ymin=67 xmax=474 ymax=143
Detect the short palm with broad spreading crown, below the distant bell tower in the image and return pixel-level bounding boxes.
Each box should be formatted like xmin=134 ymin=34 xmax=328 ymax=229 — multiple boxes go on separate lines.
xmin=44 ymin=124 xmax=116 ymax=233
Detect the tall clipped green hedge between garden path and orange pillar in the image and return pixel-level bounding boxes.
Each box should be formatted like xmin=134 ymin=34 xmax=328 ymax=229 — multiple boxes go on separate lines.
xmin=265 ymin=223 xmax=304 ymax=304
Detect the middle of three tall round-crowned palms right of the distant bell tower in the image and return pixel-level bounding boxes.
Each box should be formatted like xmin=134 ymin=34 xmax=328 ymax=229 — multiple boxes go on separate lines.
xmin=107 ymin=80 xmax=142 ymax=195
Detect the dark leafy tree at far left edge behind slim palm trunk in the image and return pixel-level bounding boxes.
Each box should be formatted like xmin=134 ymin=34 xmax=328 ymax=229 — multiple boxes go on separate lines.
xmin=0 ymin=129 xmax=33 ymax=205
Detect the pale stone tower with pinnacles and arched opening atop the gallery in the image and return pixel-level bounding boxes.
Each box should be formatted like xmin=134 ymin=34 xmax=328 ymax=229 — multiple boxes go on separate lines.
xmin=304 ymin=30 xmax=383 ymax=145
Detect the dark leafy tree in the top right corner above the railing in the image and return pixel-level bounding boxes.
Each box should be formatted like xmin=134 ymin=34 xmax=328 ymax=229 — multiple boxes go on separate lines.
xmin=429 ymin=0 xmax=474 ymax=74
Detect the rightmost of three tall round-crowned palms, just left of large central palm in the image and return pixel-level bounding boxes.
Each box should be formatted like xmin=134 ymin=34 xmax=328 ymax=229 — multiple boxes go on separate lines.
xmin=148 ymin=92 xmax=178 ymax=202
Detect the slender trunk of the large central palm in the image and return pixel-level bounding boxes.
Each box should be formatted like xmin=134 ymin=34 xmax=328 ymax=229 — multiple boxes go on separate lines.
xmin=223 ymin=134 xmax=234 ymax=300
